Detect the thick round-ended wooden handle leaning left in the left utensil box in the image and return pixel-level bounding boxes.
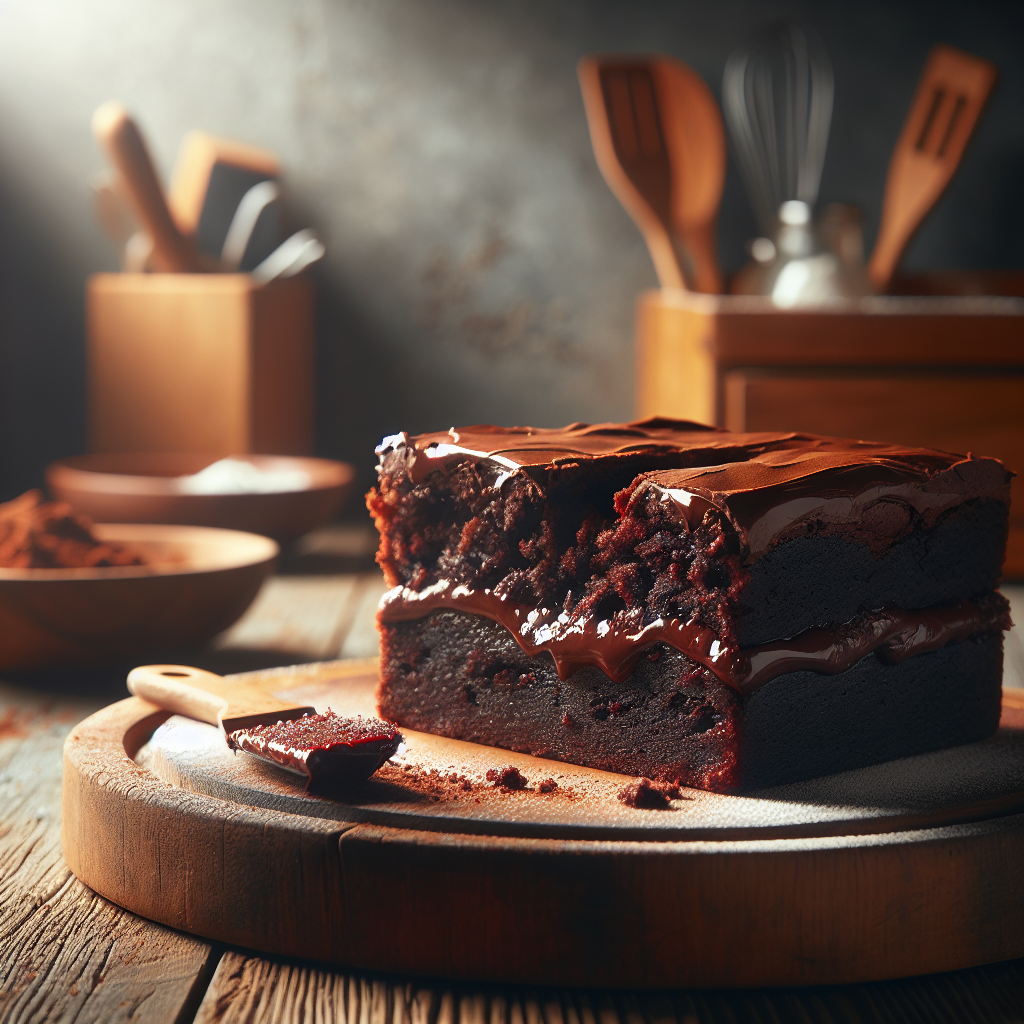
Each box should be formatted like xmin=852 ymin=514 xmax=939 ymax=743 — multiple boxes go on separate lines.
xmin=92 ymin=102 xmax=202 ymax=273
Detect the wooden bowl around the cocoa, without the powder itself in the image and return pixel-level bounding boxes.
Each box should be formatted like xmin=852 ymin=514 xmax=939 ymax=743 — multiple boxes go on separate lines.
xmin=0 ymin=523 xmax=279 ymax=672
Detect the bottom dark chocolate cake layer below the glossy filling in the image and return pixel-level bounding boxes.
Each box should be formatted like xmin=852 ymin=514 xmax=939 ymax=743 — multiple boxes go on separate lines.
xmin=378 ymin=610 xmax=1002 ymax=791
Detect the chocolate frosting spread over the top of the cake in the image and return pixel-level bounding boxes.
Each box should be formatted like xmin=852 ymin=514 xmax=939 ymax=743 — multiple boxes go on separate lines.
xmin=377 ymin=419 xmax=1011 ymax=563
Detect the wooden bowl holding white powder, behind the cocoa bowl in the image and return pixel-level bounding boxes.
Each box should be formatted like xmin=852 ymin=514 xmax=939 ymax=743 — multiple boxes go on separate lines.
xmin=46 ymin=452 xmax=355 ymax=543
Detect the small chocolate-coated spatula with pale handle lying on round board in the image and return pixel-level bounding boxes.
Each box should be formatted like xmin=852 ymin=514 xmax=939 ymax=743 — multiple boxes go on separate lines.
xmin=128 ymin=665 xmax=402 ymax=792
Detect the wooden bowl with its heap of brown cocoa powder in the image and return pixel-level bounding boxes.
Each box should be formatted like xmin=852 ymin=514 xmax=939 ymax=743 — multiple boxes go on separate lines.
xmin=0 ymin=490 xmax=279 ymax=672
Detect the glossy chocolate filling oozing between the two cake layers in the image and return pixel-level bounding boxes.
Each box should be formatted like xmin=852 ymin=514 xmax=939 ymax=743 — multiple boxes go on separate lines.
xmin=378 ymin=581 xmax=1008 ymax=694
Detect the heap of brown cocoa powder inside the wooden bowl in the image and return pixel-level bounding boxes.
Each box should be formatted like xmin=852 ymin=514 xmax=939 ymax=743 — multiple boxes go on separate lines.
xmin=0 ymin=490 xmax=145 ymax=569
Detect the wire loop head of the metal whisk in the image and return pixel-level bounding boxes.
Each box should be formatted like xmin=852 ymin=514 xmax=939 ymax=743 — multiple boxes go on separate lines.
xmin=722 ymin=24 xmax=834 ymax=237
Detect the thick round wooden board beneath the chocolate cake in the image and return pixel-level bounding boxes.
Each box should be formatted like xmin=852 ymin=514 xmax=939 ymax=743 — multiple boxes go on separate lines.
xmin=63 ymin=663 xmax=1024 ymax=988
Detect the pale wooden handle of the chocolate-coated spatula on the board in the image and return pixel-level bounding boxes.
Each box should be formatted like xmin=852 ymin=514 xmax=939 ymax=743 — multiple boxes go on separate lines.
xmin=128 ymin=665 xmax=314 ymax=732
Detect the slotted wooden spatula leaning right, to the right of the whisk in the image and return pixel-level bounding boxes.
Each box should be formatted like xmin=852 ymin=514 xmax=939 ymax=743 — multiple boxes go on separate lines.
xmin=867 ymin=46 xmax=997 ymax=292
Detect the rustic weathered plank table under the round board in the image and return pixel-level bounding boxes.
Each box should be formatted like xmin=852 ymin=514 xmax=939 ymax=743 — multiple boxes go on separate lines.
xmin=0 ymin=527 xmax=1024 ymax=1024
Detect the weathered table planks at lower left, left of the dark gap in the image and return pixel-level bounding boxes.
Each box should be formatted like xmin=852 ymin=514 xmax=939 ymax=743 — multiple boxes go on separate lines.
xmin=0 ymin=686 xmax=213 ymax=1022
